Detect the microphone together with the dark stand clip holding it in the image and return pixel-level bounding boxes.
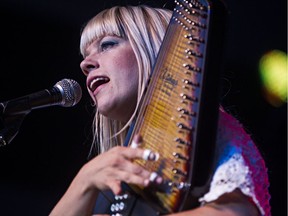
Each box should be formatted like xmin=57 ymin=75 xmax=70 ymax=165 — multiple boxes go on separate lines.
xmin=0 ymin=79 xmax=82 ymax=147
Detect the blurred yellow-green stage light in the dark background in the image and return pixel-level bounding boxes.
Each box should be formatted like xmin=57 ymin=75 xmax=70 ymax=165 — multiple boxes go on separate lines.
xmin=259 ymin=50 xmax=287 ymax=107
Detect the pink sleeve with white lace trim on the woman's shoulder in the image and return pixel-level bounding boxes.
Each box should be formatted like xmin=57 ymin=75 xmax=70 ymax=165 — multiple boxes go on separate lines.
xmin=199 ymin=112 xmax=271 ymax=216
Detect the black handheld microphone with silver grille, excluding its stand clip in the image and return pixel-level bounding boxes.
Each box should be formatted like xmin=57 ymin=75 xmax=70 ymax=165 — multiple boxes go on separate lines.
xmin=0 ymin=79 xmax=82 ymax=116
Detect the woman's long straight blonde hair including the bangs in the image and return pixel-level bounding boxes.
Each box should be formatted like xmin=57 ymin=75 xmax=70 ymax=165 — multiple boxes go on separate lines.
xmin=80 ymin=5 xmax=172 ymax=152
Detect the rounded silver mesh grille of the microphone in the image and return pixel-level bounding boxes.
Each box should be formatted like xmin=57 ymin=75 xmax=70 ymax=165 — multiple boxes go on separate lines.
xmin=54 ymin=79 xmax=82 ymax=107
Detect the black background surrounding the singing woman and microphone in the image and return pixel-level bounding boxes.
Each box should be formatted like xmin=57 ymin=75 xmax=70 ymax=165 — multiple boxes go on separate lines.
xmin=0 ymin=0 xmax=287 ymax=216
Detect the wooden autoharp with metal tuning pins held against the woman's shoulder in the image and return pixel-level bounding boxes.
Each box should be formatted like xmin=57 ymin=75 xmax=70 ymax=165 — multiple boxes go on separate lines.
xmin=107 ymin=0 xmax=226 ymax=215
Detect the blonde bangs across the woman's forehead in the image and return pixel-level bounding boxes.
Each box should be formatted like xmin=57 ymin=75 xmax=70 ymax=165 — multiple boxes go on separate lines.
xmin=80 ymin=8 xmax=127 ymax=56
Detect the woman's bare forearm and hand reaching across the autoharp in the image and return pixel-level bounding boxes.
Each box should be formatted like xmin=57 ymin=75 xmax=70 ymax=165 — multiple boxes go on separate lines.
xmin=50 ymin=147 xmax=150 ymax=216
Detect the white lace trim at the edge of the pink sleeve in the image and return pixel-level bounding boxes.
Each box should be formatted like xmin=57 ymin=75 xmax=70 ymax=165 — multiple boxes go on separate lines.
xmin=199 ymin=153 xmax=265 ymax=215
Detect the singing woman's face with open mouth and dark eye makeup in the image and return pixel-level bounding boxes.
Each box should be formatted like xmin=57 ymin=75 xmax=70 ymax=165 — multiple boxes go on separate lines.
xmin=80 ymin=35 xmax=138 ymax=122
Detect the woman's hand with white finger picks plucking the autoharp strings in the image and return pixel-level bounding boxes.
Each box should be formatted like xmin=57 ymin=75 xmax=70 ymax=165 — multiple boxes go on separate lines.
xmin=79 ymin=136 xmax=161 ymax=194
